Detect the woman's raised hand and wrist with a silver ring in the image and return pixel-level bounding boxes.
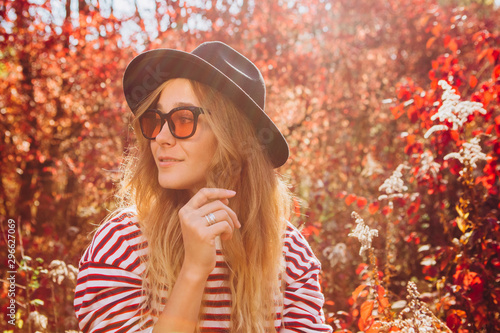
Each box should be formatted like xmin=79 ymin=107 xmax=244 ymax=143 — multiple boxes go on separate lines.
xmin=179 ymin=188 xmax=241 ymax=279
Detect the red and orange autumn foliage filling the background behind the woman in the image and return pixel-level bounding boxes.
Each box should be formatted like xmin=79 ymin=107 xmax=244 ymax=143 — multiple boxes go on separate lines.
xmin=0 ymin=0 xmax=500 ymax=332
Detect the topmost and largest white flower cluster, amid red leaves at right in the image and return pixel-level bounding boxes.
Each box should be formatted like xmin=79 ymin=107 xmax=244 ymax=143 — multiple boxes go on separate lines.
xmin=424 ymin=80 xmax=486 ymax=138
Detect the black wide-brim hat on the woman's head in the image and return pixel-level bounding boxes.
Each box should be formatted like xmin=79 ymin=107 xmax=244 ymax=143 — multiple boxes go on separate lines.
xmin=123 ymin=42 xmax=289 ymax=168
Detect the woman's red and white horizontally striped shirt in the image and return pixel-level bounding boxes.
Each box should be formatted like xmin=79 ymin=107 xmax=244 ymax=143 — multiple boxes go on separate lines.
xmin=74 ymin=211 xmax=332 ymax=333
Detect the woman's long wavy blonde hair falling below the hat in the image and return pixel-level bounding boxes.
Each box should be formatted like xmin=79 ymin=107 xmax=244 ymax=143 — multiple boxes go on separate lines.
xmin=119 ymin=81 xmax=290 ymax=332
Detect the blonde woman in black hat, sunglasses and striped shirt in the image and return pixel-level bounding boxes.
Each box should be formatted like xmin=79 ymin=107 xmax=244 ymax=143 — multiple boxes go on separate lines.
xmin=75 ymin=42 xmax=331 ymax=332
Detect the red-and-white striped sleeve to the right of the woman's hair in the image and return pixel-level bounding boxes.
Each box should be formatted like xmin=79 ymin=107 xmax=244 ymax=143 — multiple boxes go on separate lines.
xmin=280 ymin=224 xmax=333 ymax=333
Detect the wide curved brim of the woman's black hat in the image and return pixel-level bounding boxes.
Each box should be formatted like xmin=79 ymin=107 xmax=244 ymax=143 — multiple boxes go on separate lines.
xmin=123 ymin=49 xmax=289 ymax=168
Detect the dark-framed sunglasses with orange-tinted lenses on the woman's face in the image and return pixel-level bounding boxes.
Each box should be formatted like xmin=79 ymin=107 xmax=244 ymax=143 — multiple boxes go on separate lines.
xmin=139 ymin=106 xmax=204 ymax=140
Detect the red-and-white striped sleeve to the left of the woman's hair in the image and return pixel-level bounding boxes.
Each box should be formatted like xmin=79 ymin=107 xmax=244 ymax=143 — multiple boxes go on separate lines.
xmin=74 ymin=213 xmax=154 ymax=333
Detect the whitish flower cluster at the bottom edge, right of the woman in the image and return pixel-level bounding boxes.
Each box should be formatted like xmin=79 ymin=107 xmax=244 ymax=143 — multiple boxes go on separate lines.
xmin=380 ymin=281 xmax=451 ymax=333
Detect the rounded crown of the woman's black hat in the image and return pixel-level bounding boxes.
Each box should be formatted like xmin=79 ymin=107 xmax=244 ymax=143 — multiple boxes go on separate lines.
xmin=191 ymin=41 xmax=266 ymax=110
